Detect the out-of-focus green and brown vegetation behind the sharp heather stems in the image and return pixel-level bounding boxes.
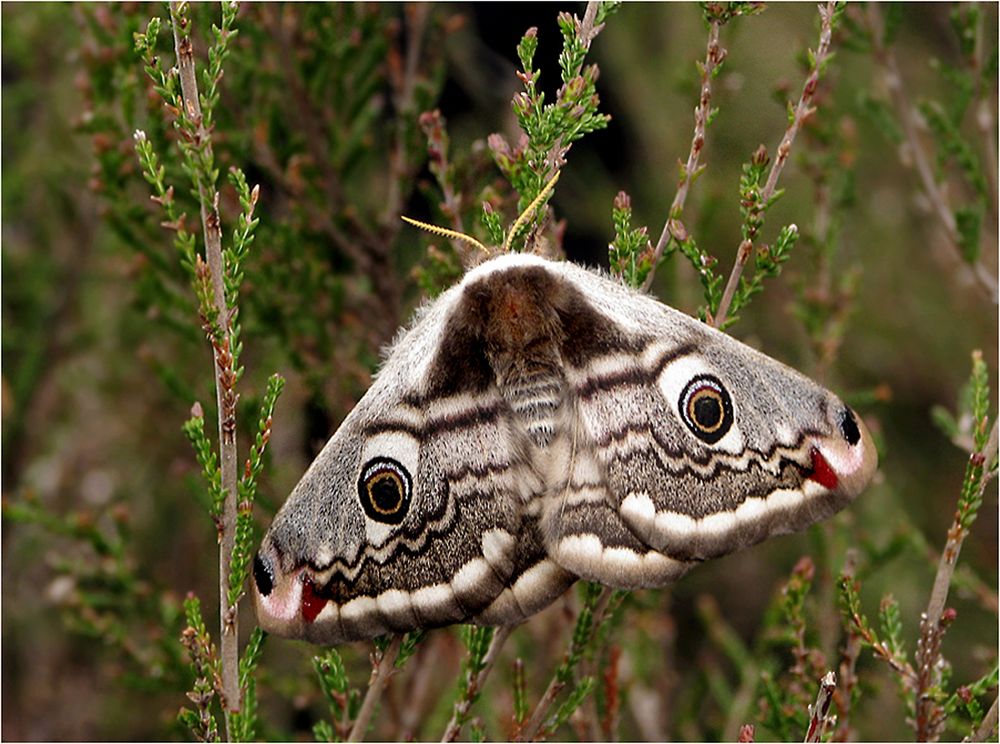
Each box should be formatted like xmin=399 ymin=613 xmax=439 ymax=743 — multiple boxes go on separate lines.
xmin=2 ymin=3 xmax=997 ymax=740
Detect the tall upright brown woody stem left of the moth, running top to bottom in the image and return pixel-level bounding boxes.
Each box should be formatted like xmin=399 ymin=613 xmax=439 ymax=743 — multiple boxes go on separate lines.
xmin=170 ymin=0 xmax=240 ymax=740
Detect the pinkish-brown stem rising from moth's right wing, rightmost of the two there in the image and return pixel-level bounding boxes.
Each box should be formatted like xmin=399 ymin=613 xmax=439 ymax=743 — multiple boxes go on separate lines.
xmin=712 ymin=0 xmax=837 ymax=328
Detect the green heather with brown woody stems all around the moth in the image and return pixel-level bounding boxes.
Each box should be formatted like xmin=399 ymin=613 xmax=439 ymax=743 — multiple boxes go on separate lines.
xmin=3 ymin=2 xmax=997 ymax=741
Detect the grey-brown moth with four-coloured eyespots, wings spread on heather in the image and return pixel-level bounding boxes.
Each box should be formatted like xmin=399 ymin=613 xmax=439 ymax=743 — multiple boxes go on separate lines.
xmin=253 ymin=254 xmax=877 ymax=644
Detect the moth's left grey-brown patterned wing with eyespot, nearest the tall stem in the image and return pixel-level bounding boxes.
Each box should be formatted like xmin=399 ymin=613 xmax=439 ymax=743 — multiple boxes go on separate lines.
xmin=254 ymin=284 xmax=574 ymax=644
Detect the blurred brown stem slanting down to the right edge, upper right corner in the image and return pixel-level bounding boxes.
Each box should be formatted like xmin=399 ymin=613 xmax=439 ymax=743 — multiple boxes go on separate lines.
xmin=867 ymin=3 xmax=1000 ymax=303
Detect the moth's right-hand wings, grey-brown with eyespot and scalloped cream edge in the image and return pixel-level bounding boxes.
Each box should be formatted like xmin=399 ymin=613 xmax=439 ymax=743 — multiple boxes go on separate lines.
xmin=545 ymin=265 xmax=877 ymax=586
